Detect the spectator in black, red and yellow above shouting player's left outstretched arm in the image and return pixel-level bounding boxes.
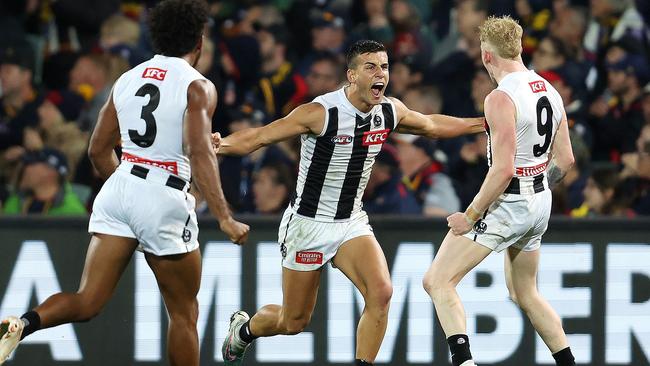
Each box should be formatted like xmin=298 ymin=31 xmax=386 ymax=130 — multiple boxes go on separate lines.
xmin=257 ymin=25 xmax=307 ymax=120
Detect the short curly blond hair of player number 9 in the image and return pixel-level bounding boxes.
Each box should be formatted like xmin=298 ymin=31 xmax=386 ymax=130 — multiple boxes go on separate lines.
xmin=478 ymin=15 xmax=524 ymax=60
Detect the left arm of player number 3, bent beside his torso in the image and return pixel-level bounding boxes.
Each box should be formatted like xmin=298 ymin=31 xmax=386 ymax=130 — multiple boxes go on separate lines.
xmin=88 ymin=91 xmax=120 ymax=179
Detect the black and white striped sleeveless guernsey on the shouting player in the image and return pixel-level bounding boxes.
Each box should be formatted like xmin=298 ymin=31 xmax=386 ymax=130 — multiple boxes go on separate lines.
xmin=292 ymin=88 xmax=397 ymax=221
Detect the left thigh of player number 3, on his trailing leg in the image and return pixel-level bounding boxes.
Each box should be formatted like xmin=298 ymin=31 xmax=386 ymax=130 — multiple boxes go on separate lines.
xmin=78 ymin=234 xmax=138 ymax=306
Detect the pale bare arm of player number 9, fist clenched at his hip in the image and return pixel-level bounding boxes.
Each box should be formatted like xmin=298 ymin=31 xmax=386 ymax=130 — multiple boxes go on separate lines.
xmin=447 ymin=90 xmax=517 ymax=235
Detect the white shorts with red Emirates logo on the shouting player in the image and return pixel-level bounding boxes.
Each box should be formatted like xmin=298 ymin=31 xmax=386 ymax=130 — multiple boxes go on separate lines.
xmin=278 ymin=207 xmax=374 ymax=271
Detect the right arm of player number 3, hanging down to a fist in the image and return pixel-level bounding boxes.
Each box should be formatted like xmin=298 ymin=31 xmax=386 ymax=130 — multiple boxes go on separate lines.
xmin=183 ymin=80 xmax=249 ymax=244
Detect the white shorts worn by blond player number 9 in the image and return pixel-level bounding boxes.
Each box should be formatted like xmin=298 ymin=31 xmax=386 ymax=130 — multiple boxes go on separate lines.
xmin=464 ymin=189 xmax=552 ymax=252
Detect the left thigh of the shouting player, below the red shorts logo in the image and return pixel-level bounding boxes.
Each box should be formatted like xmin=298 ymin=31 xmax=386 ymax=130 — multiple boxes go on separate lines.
xmin=282 ymin=267 xmax=321 ymax=320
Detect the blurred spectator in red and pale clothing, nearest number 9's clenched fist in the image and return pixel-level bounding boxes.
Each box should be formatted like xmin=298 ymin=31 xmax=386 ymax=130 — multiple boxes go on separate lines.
xmin=397 ymin=135 xmax=460 ymax=217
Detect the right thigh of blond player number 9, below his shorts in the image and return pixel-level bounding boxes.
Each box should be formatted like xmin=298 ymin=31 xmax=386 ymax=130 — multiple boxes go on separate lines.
xmin=505 ymin=247 xmax=539 ymax=302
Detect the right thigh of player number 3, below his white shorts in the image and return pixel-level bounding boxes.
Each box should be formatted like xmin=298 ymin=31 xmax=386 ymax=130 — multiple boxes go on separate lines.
xmin=145 ymin=249 xmax=201 ymax=313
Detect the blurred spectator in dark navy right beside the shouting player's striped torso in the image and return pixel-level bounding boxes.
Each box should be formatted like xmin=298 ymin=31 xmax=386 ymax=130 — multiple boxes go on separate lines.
xmin=363 ymin=144 xmax=421 ymax=214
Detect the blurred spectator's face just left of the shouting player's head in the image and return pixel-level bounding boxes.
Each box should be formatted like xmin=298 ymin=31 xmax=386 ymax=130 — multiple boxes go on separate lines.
xmin=305 ymin=53 xmax=344 ymax=100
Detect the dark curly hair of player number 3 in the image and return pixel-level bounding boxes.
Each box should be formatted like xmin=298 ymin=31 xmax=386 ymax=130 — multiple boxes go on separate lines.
xmin=149 ymin=0 xmax=208 ymax=57
